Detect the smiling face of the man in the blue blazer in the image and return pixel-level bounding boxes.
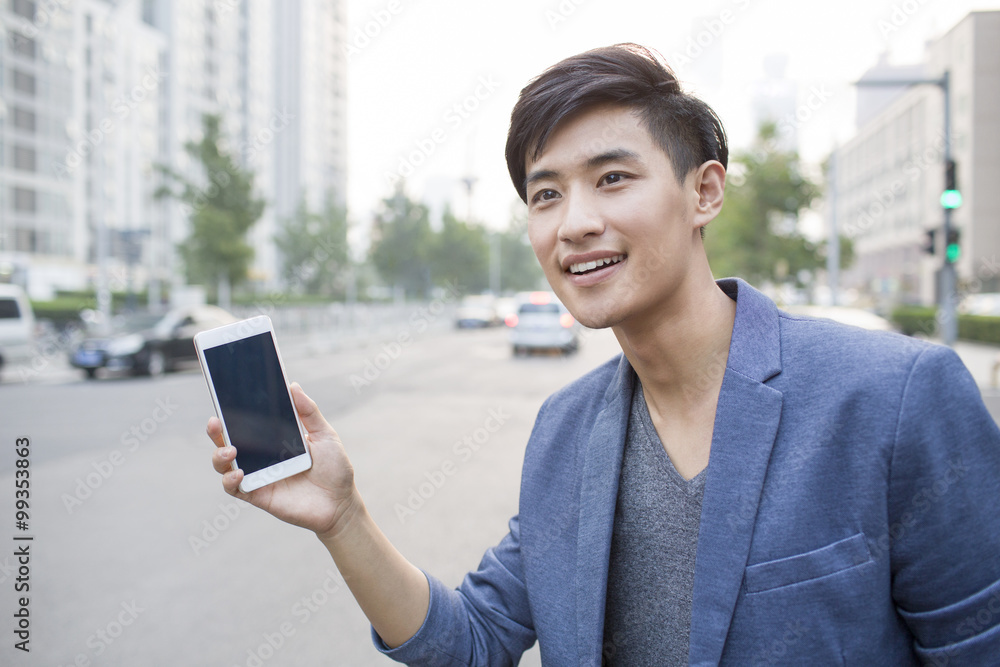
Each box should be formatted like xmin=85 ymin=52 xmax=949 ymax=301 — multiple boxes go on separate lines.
xmin=526 ymin=106 xmax=707 ymax=328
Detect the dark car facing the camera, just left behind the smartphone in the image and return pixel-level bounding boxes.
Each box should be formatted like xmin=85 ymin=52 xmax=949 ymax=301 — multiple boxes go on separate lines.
xmin=70 ymin=306 xmax=237 ymax=380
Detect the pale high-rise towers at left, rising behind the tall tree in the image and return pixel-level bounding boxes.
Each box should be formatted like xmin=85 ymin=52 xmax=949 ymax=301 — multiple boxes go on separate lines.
xmin=0 ymin=0 xmax=346 ymax=298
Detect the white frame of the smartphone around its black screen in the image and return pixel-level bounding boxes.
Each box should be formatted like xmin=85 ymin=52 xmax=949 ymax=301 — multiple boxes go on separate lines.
xmin=194 ymin=315 xmax=312 ymax=493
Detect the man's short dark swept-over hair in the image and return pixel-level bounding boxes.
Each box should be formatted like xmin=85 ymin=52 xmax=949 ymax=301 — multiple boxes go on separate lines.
xmin=506 ymin=44 xmax=729 ymax=202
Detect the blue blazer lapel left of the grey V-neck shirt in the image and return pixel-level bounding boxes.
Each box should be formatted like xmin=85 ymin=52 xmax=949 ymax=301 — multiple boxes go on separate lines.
xmin=576 ymin=355 xmax=634 ymax=667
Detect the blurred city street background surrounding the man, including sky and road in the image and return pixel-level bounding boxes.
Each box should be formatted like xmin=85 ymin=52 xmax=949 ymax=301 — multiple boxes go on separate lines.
xmin=0 ymin=0 xmax=1000 ymax=666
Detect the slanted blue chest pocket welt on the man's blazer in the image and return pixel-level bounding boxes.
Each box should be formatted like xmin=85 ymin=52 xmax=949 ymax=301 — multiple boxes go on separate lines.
xmin=743 ymin=533 xmax=872 ymax=593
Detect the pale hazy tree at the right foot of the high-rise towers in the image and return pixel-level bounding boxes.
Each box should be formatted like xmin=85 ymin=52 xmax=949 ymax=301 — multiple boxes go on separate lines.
xmin=274 ymin=197 xmax=348 ymax=298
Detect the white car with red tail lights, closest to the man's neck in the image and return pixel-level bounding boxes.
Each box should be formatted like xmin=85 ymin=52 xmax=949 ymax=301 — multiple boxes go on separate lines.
xmin=505 ymin=292 xmax=580 ymax=355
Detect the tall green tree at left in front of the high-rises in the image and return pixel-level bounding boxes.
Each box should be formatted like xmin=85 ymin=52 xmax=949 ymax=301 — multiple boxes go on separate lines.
xmin=155 ymin=114 xmax=265 ymax=297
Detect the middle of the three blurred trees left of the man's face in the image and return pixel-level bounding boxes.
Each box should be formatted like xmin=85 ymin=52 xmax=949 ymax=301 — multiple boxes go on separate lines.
xmin=428 ymin=209 xmax=490 ymax=294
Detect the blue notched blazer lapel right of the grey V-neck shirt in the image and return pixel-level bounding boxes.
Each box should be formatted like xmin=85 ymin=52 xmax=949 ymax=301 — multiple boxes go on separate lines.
xmin=689 ymin=281 xmax=782 ymax=665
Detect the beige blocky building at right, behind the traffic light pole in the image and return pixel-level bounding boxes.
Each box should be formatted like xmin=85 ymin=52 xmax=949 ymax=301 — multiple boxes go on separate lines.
xmin=829 ymin=11 xmax=1000 ymax=307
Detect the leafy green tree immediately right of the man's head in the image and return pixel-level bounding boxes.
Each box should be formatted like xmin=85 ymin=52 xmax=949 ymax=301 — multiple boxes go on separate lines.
xmin=705 ymin=123 xmax=825 ymax=284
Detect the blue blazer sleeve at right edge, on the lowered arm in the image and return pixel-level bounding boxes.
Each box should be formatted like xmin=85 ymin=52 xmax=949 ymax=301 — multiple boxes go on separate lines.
xmin=887 ymin=345 xmax=1000 ymax=667
